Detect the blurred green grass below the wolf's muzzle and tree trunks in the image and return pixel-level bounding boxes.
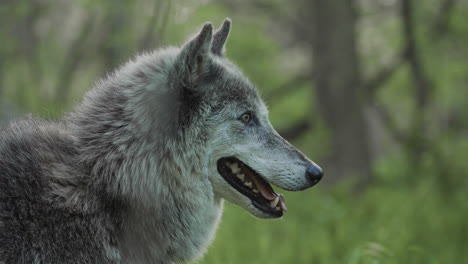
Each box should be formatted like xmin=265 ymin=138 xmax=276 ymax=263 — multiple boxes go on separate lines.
xmin=199 ymin=175 xmax=468 ymax=264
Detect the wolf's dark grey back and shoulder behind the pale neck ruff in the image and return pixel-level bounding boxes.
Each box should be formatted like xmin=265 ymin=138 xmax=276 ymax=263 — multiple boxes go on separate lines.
xmin=0 ymin=117 xmax=119 ymax=263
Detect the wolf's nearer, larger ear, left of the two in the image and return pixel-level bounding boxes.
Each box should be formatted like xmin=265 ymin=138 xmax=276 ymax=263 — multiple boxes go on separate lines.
xmin=178 ymin=23 xmax=213 ymax=84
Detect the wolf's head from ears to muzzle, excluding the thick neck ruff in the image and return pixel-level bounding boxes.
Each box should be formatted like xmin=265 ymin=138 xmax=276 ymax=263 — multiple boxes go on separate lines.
xmin=166 ymin=19 xmax=323 ymax=218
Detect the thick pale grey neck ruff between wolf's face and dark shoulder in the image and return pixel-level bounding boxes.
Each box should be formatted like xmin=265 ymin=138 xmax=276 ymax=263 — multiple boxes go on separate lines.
xmin=69 ymin=49 xmax=222 ymax=263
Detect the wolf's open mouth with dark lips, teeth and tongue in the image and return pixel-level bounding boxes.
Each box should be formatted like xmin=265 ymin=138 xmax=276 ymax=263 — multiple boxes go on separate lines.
xmin=217 ymin=157 xmax=288 ymax=217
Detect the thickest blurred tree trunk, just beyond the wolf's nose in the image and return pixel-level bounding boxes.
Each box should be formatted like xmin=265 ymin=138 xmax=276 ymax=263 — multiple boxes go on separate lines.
xmin=307 ymin=0 xmax=371 ymax=186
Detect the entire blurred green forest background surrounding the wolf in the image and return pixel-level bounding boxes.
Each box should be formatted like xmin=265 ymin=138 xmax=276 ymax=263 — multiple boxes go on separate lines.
xmin=0 ymin=0 xmax=468 ymax=264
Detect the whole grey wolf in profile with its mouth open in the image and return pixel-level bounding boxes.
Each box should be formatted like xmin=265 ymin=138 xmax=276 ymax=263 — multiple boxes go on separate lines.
xmin=0 ymin=19 xmax=323 ymax=263
